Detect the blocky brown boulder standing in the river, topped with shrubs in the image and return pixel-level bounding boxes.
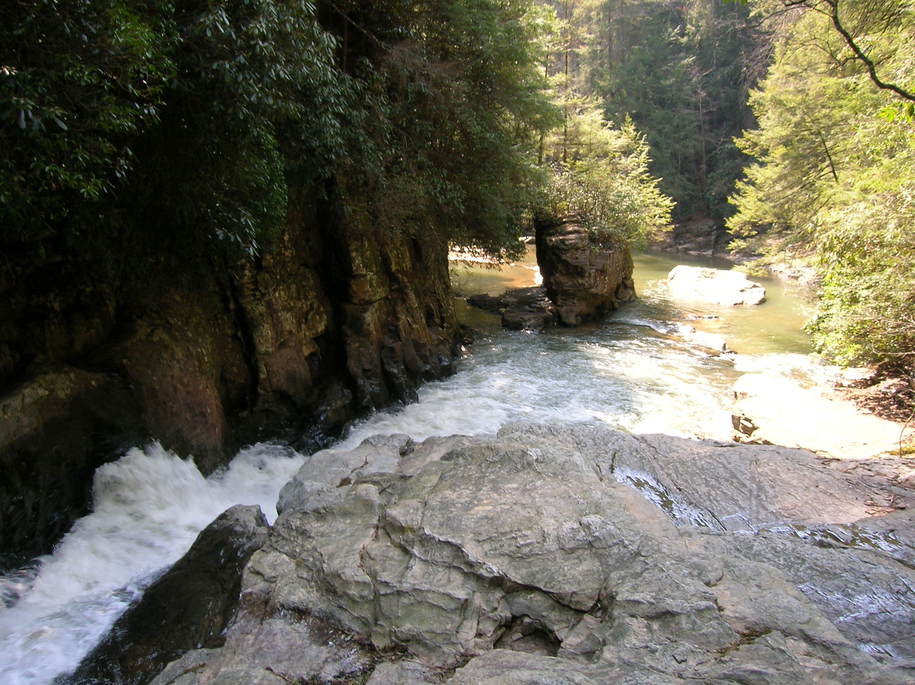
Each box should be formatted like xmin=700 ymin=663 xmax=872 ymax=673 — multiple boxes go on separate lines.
xmin=537 ymin=218 xmax=635 ymax=326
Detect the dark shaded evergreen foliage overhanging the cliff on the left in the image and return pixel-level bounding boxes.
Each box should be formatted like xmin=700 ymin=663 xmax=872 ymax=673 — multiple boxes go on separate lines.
xmin=0 ymin=0 xmax=554 ymax=255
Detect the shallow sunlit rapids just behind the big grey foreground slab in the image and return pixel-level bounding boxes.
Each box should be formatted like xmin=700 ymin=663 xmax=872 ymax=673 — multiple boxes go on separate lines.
xmin=344 ymin=322 xmax=736 ymax=447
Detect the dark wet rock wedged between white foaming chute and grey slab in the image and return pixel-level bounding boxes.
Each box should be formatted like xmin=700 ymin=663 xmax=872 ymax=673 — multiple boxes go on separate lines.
xmin=65 ymin=505 xmax=269 ymax=685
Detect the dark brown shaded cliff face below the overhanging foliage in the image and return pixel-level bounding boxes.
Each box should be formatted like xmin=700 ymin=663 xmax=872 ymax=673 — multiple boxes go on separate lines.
xmin=0 ymin=184 xmax=456 ymax=567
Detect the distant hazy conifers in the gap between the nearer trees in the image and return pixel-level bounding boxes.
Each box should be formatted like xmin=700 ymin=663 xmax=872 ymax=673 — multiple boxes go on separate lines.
xmin=565 ymin=0 xmax=766 ymax=219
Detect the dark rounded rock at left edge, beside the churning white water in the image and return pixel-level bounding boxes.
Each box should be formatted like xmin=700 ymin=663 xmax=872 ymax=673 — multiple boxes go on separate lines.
xmin=0 ymin=366 xmax=143 ymax=570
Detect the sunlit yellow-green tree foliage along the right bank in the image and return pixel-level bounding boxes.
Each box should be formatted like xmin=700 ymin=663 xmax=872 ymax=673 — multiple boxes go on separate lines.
xmin=729 ymin=0 xmax=915 ymax=363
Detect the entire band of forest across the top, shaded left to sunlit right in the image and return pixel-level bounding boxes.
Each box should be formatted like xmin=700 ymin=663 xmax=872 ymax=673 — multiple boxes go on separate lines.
xmin=0 ymin=0 xmax=915 ymax=366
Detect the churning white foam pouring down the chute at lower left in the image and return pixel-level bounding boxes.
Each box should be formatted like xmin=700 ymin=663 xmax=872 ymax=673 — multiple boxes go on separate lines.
xmin=0 ymin=444 xmax=304 ymax=685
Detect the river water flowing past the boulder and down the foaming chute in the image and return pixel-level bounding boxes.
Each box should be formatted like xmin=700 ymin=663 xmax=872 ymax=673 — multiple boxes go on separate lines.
xmin=0 ymin=248 xmax=807 ymax=685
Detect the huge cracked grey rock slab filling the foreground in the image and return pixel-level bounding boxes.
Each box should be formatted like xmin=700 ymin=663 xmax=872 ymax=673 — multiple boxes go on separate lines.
xmin=155 ymin=424 xmax=915 ymax=685
